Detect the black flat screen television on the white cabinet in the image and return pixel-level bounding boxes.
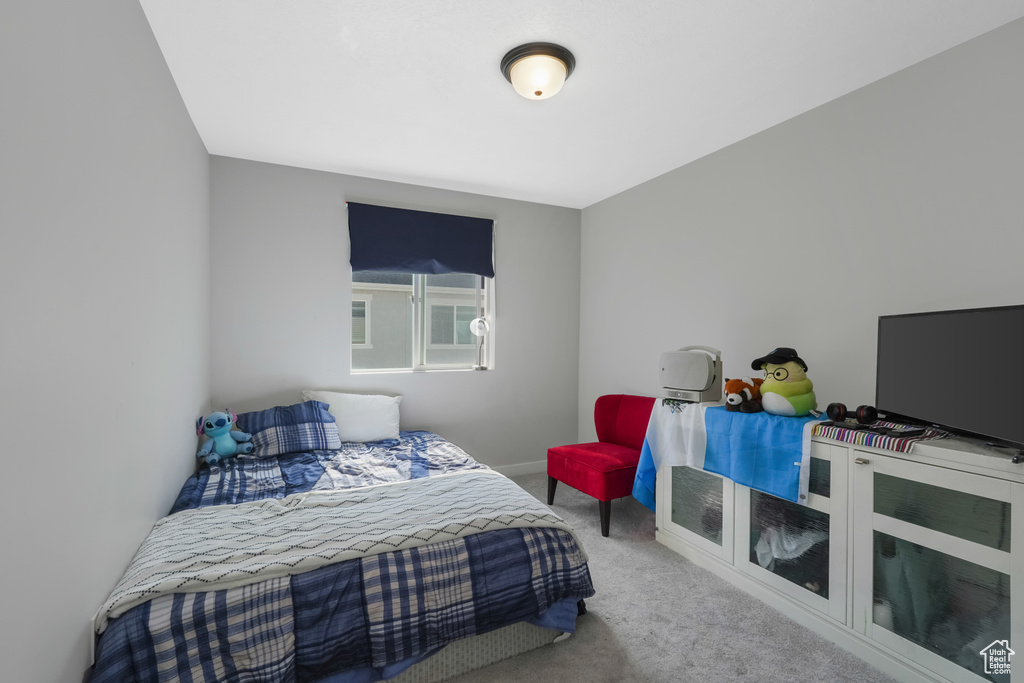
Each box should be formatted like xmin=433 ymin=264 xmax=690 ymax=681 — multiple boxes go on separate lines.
xmin=874 ymin=305 xmax=1024 ymax=450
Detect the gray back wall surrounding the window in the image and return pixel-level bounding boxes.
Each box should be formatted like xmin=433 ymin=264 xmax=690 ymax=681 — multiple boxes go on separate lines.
xmin=210 ymin=156 xmax=580 ymax=471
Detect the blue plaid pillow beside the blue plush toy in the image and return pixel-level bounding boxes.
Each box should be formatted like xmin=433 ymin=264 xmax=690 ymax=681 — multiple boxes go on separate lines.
xmin=237 ymin=400 xmax=341 ymax=458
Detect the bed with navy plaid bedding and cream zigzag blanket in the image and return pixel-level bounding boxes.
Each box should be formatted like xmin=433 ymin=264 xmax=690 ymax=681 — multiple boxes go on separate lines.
xmin=90 ymin=400 xmax=594 ymax=683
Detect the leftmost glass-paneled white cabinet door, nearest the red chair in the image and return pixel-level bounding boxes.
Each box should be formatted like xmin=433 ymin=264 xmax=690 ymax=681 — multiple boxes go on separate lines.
xmin=657 ymin=466 xmax=735 ymax=562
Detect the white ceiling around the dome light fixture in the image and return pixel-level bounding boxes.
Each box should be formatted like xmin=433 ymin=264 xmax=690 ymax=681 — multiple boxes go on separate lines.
xmin=140 ymin=0 xmax=1024 ymax=208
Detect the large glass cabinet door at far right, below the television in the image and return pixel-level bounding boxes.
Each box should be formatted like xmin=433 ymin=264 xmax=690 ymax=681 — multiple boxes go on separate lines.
xmin=854 ymin=452 xmax=1024 ymax=683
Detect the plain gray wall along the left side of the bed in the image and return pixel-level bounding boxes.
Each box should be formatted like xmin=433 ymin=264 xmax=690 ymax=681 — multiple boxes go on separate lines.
xmin=0 ymin=0 xmax=209 ymax=681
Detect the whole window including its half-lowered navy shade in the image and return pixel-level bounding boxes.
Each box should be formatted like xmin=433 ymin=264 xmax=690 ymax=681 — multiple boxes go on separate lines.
xmin=346 ymin=202 xmax=495 ymax=372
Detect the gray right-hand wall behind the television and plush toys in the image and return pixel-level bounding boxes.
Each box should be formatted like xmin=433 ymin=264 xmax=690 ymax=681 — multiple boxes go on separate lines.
xmin=579 ymin=19 xmax=1024 ymax=437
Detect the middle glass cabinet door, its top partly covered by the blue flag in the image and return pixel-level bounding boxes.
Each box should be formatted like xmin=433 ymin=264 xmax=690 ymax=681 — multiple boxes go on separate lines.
xmin=735 ymin=443 xmax=848 ymax=623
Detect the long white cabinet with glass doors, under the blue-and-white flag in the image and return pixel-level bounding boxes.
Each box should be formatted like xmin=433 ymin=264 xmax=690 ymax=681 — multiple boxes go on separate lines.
xmin=657 ymin=437 xmax=1024 ymax=683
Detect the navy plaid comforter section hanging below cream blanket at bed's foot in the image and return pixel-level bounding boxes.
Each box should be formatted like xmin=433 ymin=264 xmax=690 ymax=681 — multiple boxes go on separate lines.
xmin=91 ymin=528 xmax=594 ymax=683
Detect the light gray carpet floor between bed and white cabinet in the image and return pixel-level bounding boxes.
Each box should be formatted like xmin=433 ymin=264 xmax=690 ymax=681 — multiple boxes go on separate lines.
xmin=452 ymin=474 xmax=892 ymax=683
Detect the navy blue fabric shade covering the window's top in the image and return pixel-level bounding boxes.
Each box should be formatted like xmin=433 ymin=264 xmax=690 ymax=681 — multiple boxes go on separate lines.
xmin=348 ymin=202 xmax=495 ymax=278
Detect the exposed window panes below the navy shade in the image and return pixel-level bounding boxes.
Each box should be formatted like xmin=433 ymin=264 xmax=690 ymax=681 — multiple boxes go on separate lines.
xmin=351 ymin=270 xmax=494 ymax=372
